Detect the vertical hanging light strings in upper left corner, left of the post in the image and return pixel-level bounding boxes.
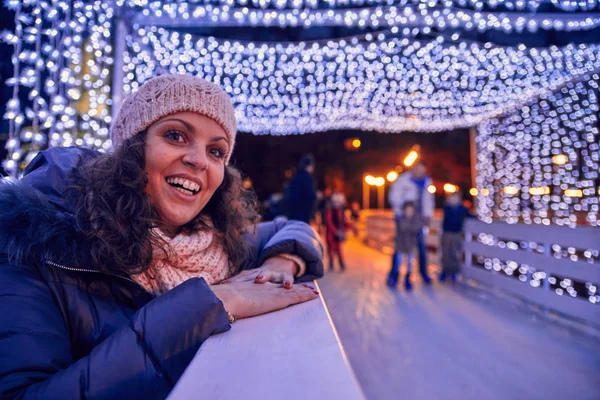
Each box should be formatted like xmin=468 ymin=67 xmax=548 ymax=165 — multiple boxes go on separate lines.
xmin=2 ymin=0 xmax=113 ymax=175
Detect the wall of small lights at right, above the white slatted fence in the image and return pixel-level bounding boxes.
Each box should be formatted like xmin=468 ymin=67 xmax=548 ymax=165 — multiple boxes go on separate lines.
xmin=476 ymin=74 xmax=600 ymax=226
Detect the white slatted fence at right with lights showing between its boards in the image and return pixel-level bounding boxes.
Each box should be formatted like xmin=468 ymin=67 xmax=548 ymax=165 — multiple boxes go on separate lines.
xmin=463 ymin=220 xmax=600 ymax=325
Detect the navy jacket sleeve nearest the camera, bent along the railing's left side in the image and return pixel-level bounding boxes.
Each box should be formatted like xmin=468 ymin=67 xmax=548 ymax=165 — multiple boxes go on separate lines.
xmin=0 ymin=263 xmax=230 ymax=400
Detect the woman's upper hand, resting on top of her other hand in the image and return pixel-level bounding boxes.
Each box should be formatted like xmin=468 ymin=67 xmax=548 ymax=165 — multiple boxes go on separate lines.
xmin=221 ymin=257 xmax=299 ymax=289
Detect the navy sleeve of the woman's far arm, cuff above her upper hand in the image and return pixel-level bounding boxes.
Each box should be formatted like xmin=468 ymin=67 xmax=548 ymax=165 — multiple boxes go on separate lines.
xmin=242 ymin=218 xmax=323 ymax=281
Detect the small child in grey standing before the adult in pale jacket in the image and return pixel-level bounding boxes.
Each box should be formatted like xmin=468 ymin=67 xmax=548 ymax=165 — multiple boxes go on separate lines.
xmin=387 ymin=201 xmax=424 ymax=290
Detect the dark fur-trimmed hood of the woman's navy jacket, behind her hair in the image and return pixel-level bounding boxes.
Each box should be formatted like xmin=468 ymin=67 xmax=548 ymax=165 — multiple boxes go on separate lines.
xmin=0 ymin=147 xmax=99 ymax=265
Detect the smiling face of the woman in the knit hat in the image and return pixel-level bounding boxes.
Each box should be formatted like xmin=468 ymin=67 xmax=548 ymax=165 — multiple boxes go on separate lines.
xmin=145 ymin=112 xmax=230 ymax=229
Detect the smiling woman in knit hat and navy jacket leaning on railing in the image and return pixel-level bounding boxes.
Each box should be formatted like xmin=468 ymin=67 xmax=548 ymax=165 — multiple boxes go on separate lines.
xmin=0 ymin=76 xmax=323 ymax=399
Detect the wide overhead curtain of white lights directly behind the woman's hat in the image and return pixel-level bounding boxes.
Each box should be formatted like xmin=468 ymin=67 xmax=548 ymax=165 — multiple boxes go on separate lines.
xmin=124 ymin=27 xmax=600 ymax=134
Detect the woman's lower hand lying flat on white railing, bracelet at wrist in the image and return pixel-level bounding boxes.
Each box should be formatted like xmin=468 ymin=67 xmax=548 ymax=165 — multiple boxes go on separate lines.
xmin=211 ymin=282 xmax=319 ymax=319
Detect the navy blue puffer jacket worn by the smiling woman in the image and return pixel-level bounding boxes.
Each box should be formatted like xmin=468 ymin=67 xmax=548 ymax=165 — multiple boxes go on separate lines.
xmin=0 ymin=148 xmax=323 ymax=400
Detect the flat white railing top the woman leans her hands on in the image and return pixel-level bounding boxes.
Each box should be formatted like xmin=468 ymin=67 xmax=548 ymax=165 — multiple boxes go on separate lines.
xmin=168 ymin=286 xmax=365 ymax=400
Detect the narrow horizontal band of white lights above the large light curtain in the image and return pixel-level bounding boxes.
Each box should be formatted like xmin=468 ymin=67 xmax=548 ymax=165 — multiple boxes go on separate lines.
xmin=127 ymin=0 xmax=600 ymax=33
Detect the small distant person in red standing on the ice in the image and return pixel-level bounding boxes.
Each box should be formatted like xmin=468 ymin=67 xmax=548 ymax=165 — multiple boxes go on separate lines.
xmin=325 ymin=193 xmax=347 ymax=271
